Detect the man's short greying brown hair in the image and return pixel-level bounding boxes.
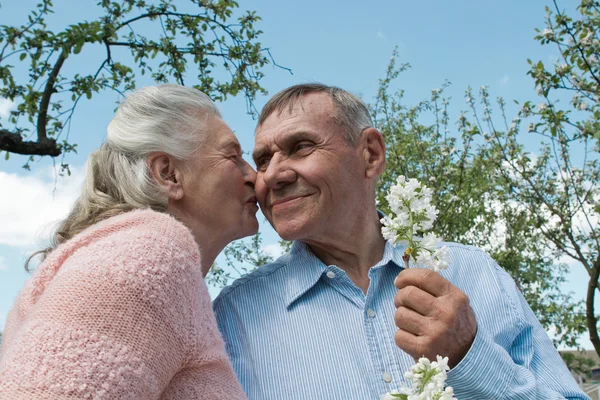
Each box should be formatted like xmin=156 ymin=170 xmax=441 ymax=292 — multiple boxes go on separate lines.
xmin=257 ymin=83 xmax=373 ymax=144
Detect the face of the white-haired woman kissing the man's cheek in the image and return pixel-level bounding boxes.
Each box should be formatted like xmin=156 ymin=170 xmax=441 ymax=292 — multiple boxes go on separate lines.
xmin=178 ymin=115 xmax=258 ymax=251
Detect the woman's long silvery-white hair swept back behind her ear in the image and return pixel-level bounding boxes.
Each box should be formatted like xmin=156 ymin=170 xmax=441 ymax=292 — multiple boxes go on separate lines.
xmin=25 ymin=84 xmax=221 ymax=269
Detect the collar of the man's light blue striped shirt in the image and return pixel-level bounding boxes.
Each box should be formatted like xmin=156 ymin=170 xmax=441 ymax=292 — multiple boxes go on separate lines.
xmin=284 ymin=241 xmax=404 ymax=308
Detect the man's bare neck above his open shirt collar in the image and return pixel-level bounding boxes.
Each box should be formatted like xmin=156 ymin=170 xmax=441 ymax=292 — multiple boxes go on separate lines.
xmin=304 ymin=210 xmax=385 ymax=293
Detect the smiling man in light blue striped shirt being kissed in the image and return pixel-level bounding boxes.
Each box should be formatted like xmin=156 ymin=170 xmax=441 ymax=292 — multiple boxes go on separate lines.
xmin=214 ymin=84 xmax=587 ymax=400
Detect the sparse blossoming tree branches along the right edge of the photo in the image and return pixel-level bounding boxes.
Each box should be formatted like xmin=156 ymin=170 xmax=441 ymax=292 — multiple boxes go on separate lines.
xmin=490 ymin=0 xmax=600 ymax=354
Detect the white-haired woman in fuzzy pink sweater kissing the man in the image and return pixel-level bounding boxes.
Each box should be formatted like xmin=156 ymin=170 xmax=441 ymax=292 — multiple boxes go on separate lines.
xmin=0 ymin=85 xmax=258 ymax=399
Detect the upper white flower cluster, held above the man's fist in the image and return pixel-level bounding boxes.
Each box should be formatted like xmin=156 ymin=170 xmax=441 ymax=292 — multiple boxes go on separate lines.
xmin=381 ymin=176 xmax=448 ymax=271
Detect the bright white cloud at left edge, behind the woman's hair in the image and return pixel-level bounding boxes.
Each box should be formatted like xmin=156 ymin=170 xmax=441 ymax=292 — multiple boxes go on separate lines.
xmin=0 ymin=167 xmax=83 ymax=248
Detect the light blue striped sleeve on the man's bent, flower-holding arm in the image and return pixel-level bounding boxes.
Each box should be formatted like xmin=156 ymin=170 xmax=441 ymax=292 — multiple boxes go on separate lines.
xmin=447 ymin=260 xmax=589 ymax=400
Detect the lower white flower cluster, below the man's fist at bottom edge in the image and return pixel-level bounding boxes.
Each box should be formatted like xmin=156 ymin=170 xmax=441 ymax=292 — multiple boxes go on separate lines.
xmin=381 ymin=356 xmax=456 ymax=400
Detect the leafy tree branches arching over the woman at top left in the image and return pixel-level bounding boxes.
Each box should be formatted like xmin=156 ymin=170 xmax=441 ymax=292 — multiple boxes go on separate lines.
xmin=0 ymin=0 xmax=286 ymax=167
